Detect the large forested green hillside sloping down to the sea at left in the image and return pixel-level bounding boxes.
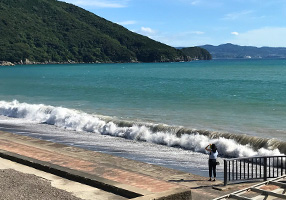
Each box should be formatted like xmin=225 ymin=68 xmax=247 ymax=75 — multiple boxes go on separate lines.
xmin=0 ymin=0 xmax=186 ymax=63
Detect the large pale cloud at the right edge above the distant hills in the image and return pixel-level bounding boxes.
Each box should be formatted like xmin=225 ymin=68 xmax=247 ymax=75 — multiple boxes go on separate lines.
xmin=230 ymin=27 xmax=286 ymax=47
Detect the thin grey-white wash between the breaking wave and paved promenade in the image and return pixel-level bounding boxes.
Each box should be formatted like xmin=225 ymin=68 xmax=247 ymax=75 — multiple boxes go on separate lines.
xmin=0 ymin=117 xmax=217 ymax=179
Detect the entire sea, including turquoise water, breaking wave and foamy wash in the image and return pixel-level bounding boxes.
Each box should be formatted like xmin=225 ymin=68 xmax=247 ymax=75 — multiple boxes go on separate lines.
xmin=0 ymin=59 xmax=286 ymax=177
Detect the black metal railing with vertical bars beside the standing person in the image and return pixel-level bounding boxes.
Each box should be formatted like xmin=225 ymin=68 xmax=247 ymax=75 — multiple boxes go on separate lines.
xmin=224 ymin=156 xmax=286 ymax=185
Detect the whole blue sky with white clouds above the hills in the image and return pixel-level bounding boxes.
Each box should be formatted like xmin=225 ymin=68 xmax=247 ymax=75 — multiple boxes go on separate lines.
xmin=61 ymin=0 xmax=286 ymax=47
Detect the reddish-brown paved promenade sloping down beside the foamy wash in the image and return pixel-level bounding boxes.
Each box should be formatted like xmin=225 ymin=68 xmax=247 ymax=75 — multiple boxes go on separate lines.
xmin=0 ymin=131 xmax=198 ymax=199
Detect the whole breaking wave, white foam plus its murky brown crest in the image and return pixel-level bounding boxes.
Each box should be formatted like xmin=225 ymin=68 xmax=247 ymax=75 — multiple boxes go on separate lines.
xmin=0 ymin=100 xmax=286 ymax=157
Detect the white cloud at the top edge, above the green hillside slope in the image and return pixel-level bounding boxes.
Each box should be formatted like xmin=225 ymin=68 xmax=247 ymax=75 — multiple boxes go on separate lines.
xmin=62 ymin=0 xmax=129 ymax=8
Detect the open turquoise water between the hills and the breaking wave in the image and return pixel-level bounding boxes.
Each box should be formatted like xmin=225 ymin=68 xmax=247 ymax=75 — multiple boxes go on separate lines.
xmin=0 ymin=60 xmax=286 ymax=141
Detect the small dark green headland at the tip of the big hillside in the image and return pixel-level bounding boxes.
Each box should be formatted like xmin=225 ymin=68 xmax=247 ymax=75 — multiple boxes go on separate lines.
xmin=180 ymin=47 xmax=212 ymax=60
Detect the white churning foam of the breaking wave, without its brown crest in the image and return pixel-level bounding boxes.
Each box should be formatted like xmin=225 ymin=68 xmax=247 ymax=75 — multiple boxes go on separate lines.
xmin=0 ymin=100 xmax=282 ymax=157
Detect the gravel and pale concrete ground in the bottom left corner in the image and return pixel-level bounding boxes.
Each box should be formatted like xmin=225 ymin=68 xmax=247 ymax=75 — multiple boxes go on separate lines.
xmin=0 ymin=158 xmax=126 ymax=200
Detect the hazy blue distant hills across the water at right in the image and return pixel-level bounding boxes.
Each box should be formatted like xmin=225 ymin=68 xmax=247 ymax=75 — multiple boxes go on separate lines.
xmin=200 ymin=43 xmax=286 ymax=59
